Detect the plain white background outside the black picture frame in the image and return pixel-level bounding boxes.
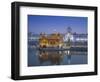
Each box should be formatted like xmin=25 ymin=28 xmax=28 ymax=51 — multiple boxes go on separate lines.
xmin=0 ymin=0 xmax=100 ymax=82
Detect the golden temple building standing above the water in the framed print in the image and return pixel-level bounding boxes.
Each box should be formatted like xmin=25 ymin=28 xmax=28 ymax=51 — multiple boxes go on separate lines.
xmin=39 ymin=33 xmax=63 ymax=48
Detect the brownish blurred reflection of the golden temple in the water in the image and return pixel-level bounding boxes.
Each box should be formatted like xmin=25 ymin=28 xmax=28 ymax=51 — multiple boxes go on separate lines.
xmin=39 ymin=51 xmax=64 ymax=65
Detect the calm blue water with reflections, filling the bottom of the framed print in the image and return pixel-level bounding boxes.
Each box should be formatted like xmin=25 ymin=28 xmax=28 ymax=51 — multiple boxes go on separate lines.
xmin=28 ymin=47 xmax=88 ymax=66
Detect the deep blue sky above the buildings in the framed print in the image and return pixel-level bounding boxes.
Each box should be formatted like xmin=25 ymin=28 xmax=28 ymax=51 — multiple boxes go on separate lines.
xmin=28 ymin=15 xmax=88 ymax=34
